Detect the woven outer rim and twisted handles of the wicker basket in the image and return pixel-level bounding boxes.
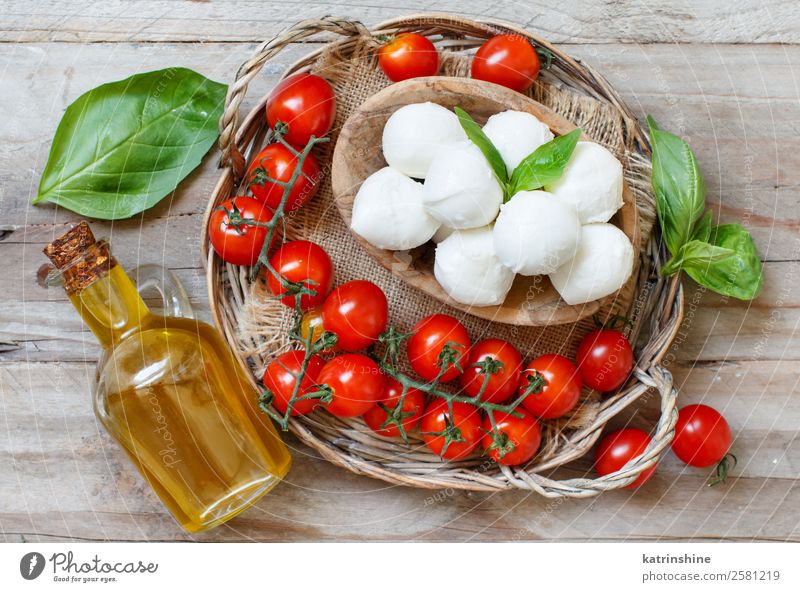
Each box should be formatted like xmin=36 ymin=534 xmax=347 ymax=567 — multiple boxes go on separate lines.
xmin=202 ymin=13 xmax=683 ymax=497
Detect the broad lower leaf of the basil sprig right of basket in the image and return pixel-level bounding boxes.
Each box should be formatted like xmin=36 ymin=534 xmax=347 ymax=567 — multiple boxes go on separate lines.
xmin=681 ymin=224 xmax=764 ymax=300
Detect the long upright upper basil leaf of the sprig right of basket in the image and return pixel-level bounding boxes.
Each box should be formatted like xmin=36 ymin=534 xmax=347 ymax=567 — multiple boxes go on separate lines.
xmin=647 ymin=116 xmax=706 ymax=255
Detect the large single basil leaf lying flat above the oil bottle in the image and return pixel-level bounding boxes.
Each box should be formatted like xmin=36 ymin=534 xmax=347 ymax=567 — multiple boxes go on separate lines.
xmin=33 ymin=68 xmax=227 ymax=220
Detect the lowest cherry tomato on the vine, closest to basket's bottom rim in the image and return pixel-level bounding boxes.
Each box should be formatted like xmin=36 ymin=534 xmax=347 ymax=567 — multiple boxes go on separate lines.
xmin=482 ymin=409 xmax=542 ymax=466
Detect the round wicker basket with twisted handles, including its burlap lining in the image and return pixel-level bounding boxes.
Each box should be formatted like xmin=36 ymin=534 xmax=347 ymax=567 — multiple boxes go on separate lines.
xmin=203 ymin=14 xmax=683 ymax=497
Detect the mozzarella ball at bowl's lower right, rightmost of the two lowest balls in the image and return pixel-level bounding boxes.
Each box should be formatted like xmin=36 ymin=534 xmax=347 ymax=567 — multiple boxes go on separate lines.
xmin=550 ymin=223 xmax=633 ymax=304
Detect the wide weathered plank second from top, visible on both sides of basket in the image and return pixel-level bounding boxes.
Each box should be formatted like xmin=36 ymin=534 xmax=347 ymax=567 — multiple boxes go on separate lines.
xmin=0 ymin=44 xmax=800 ymax=261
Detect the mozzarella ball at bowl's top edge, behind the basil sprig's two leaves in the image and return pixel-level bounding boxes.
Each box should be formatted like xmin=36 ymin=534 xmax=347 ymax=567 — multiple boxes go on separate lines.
xmin=483 ymin=111 xmax=553 ymax=175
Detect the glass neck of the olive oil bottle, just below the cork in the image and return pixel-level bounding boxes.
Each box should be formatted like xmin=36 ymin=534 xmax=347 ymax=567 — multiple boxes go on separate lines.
xmin=69 ymin=262 xmax=150 ymax=349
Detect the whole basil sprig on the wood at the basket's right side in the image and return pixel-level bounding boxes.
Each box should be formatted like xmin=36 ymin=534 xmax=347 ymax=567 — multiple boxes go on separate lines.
xmin=647 ymin=117 xmax=764 ymax=300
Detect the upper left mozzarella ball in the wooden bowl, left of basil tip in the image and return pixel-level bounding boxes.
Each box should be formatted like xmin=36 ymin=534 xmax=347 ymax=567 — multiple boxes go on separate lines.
xmin=383 ymin=103 xmax=467 ymax=179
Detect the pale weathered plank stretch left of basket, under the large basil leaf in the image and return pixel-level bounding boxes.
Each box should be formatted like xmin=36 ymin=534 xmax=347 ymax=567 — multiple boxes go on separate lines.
xmin=0 ymin=44 xmax=288 ymax=229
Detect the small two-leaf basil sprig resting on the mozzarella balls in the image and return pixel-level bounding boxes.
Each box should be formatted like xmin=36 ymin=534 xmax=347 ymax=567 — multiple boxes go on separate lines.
xmin=454 ymin=107 xmax=581 ymax=202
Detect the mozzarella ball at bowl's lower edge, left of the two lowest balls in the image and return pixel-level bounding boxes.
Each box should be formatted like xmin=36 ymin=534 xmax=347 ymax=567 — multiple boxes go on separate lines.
xmin=433 ymin=226 xmax=514 ymax=306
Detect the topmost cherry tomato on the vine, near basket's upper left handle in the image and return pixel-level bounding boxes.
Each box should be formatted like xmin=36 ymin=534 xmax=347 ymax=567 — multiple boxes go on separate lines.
xmin=267 ymin=72 xmax=336 ymax=146
